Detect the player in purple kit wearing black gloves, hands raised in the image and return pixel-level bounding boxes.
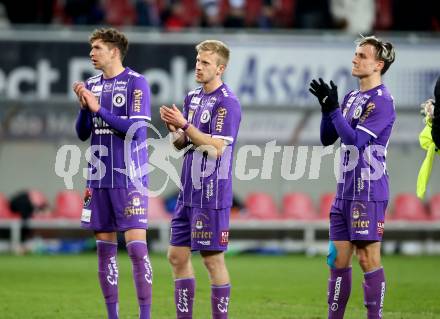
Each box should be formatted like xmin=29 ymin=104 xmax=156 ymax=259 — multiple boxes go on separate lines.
xmin=310 ymin=36 xmax=396 ymax=319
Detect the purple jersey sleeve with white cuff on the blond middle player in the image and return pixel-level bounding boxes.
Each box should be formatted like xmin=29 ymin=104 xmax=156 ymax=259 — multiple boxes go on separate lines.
xmin=211 ymin=98 xmax=241 ymax=143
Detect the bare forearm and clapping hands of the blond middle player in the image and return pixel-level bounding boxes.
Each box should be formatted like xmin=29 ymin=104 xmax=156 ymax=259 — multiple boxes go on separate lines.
xmin=161 ymin=105 xmax=225 ymax=158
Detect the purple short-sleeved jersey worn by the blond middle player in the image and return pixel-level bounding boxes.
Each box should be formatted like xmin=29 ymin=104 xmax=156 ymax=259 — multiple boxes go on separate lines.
xmin=178 ymin=84 xmax=241 ymax=209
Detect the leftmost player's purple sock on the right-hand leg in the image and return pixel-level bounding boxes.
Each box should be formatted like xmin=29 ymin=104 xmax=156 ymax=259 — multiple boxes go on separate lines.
xmin=127 ymin=240 xmax=153 ymax=319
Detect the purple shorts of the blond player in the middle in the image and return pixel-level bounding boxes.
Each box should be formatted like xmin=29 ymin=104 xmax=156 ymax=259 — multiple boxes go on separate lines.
xmin=170 ymin=204 xmax=231 ymax=251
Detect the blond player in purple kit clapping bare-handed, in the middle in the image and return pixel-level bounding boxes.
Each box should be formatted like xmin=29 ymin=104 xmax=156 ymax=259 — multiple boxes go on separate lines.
xmin=160 ymin=40 xmax=241 ymax=319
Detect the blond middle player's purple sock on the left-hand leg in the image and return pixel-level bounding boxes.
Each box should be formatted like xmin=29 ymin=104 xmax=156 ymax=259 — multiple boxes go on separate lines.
xmin=174 ymin=278 xmax=196 ymax=319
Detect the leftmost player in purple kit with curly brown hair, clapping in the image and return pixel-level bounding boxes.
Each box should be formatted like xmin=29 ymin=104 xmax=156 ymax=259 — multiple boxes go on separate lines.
xmin=73 ymin=29 xmax=152 ymax=319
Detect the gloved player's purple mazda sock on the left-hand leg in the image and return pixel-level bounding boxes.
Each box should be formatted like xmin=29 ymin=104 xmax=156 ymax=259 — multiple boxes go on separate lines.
xmin=328 ymin=267 xmax=351 ymax=319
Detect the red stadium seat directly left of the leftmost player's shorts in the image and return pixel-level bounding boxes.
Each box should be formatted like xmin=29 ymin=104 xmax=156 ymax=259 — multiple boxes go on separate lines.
xmin=54 ymin=190 xmax=83 ymax=219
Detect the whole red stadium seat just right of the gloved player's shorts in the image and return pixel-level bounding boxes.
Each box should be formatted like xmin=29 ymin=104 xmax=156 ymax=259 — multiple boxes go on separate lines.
xmin=391 ymin=193 xmax=428 ymax=221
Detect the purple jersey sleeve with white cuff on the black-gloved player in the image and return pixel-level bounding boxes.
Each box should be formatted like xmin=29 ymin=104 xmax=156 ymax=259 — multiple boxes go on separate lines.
xmin=356 ymin=96 xmax=396 ymax=138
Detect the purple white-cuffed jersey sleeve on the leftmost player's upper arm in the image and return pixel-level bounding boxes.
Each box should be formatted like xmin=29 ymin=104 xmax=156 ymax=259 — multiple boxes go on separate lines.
xmin=128 ymin=76 xmax=151 ymax=121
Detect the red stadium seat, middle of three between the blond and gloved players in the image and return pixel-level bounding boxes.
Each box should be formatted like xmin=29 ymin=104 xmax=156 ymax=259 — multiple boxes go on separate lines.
xmin=282 ymin=193 xmax=318 ymax=220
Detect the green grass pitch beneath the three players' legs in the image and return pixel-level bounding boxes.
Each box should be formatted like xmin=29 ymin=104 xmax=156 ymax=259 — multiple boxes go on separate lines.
xmin=0 ymin=253 xmax=440 ymax=319
